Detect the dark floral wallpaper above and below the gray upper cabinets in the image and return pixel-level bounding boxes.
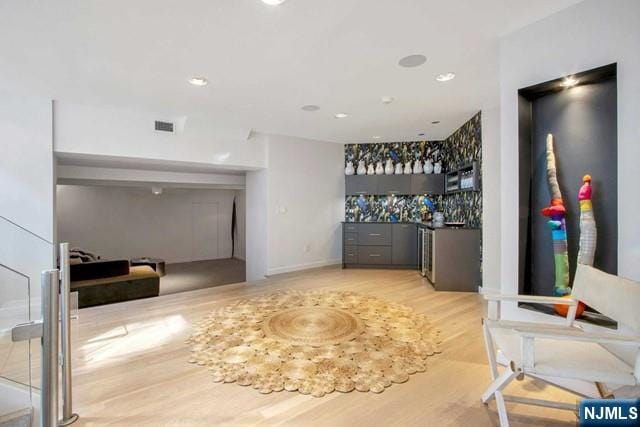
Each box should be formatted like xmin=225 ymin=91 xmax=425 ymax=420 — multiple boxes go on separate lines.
xmin=345 ymin=113 xmax=482 ymax=228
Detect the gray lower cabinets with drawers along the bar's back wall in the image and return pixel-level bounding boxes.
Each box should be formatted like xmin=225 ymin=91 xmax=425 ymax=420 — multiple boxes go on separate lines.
xmin=342 ymin=223 xmax=418 ymax=268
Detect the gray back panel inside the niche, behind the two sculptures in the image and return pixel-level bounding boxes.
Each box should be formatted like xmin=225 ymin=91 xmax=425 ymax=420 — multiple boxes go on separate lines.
xmin=521 ymin=80 xmax=618 ymax=295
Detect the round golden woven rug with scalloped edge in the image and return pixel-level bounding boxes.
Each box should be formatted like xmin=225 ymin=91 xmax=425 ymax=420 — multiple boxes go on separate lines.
xmin=187 ymin=291 xmax=439 ymax=397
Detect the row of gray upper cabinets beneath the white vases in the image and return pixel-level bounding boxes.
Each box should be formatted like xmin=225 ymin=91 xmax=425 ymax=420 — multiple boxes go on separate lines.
xmin=345 ymin=174 xmax=444 ymax=196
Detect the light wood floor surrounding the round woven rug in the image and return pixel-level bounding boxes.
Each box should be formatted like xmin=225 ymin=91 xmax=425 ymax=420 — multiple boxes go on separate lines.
xmin=67 ymin=267 xmax=575 ymax=426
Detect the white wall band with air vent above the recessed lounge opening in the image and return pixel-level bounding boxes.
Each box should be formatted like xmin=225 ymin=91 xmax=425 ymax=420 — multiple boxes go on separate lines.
xmin=54 ymin=101 xmax=266 ymax=170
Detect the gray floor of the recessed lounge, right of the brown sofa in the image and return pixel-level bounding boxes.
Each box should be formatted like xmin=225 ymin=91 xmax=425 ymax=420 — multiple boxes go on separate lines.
xmin=160 ymin=258 xmax=245 ymax=295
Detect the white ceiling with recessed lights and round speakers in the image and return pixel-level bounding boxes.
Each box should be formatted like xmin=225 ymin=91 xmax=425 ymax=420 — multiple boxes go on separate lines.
xmin=0 ymin=0 xmax=578 ymax=142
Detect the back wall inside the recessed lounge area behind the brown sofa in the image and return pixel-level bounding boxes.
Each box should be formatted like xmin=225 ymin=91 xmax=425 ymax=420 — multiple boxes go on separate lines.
xmin=57 ymin=185 xmax=245 ymax=263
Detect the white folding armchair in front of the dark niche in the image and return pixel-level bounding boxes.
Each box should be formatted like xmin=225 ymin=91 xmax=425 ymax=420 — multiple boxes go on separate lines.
xmin=482 ymin=265 xmax=640 ymax=427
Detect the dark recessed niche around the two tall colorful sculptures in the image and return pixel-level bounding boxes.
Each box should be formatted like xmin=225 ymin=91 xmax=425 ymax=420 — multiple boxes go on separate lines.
xmin=518 ymin=64 xmax=618 ymax=295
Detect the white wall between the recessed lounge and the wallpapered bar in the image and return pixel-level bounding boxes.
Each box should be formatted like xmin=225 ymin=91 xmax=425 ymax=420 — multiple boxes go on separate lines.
xmin=267 ymin=135 xmax=344 ymax=274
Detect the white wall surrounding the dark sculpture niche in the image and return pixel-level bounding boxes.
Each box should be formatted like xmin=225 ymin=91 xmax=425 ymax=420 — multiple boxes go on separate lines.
xmin=500 ymin=0 xmax=640 ymax=315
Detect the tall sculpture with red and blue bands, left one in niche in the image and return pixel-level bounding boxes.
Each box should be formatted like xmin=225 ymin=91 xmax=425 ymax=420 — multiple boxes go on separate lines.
xmin=542 ymin=134 xmax=571 ymax=296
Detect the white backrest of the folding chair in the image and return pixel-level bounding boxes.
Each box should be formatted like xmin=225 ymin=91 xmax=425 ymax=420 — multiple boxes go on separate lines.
xmin=571 ymin=264 xmax=640 ymax=334
